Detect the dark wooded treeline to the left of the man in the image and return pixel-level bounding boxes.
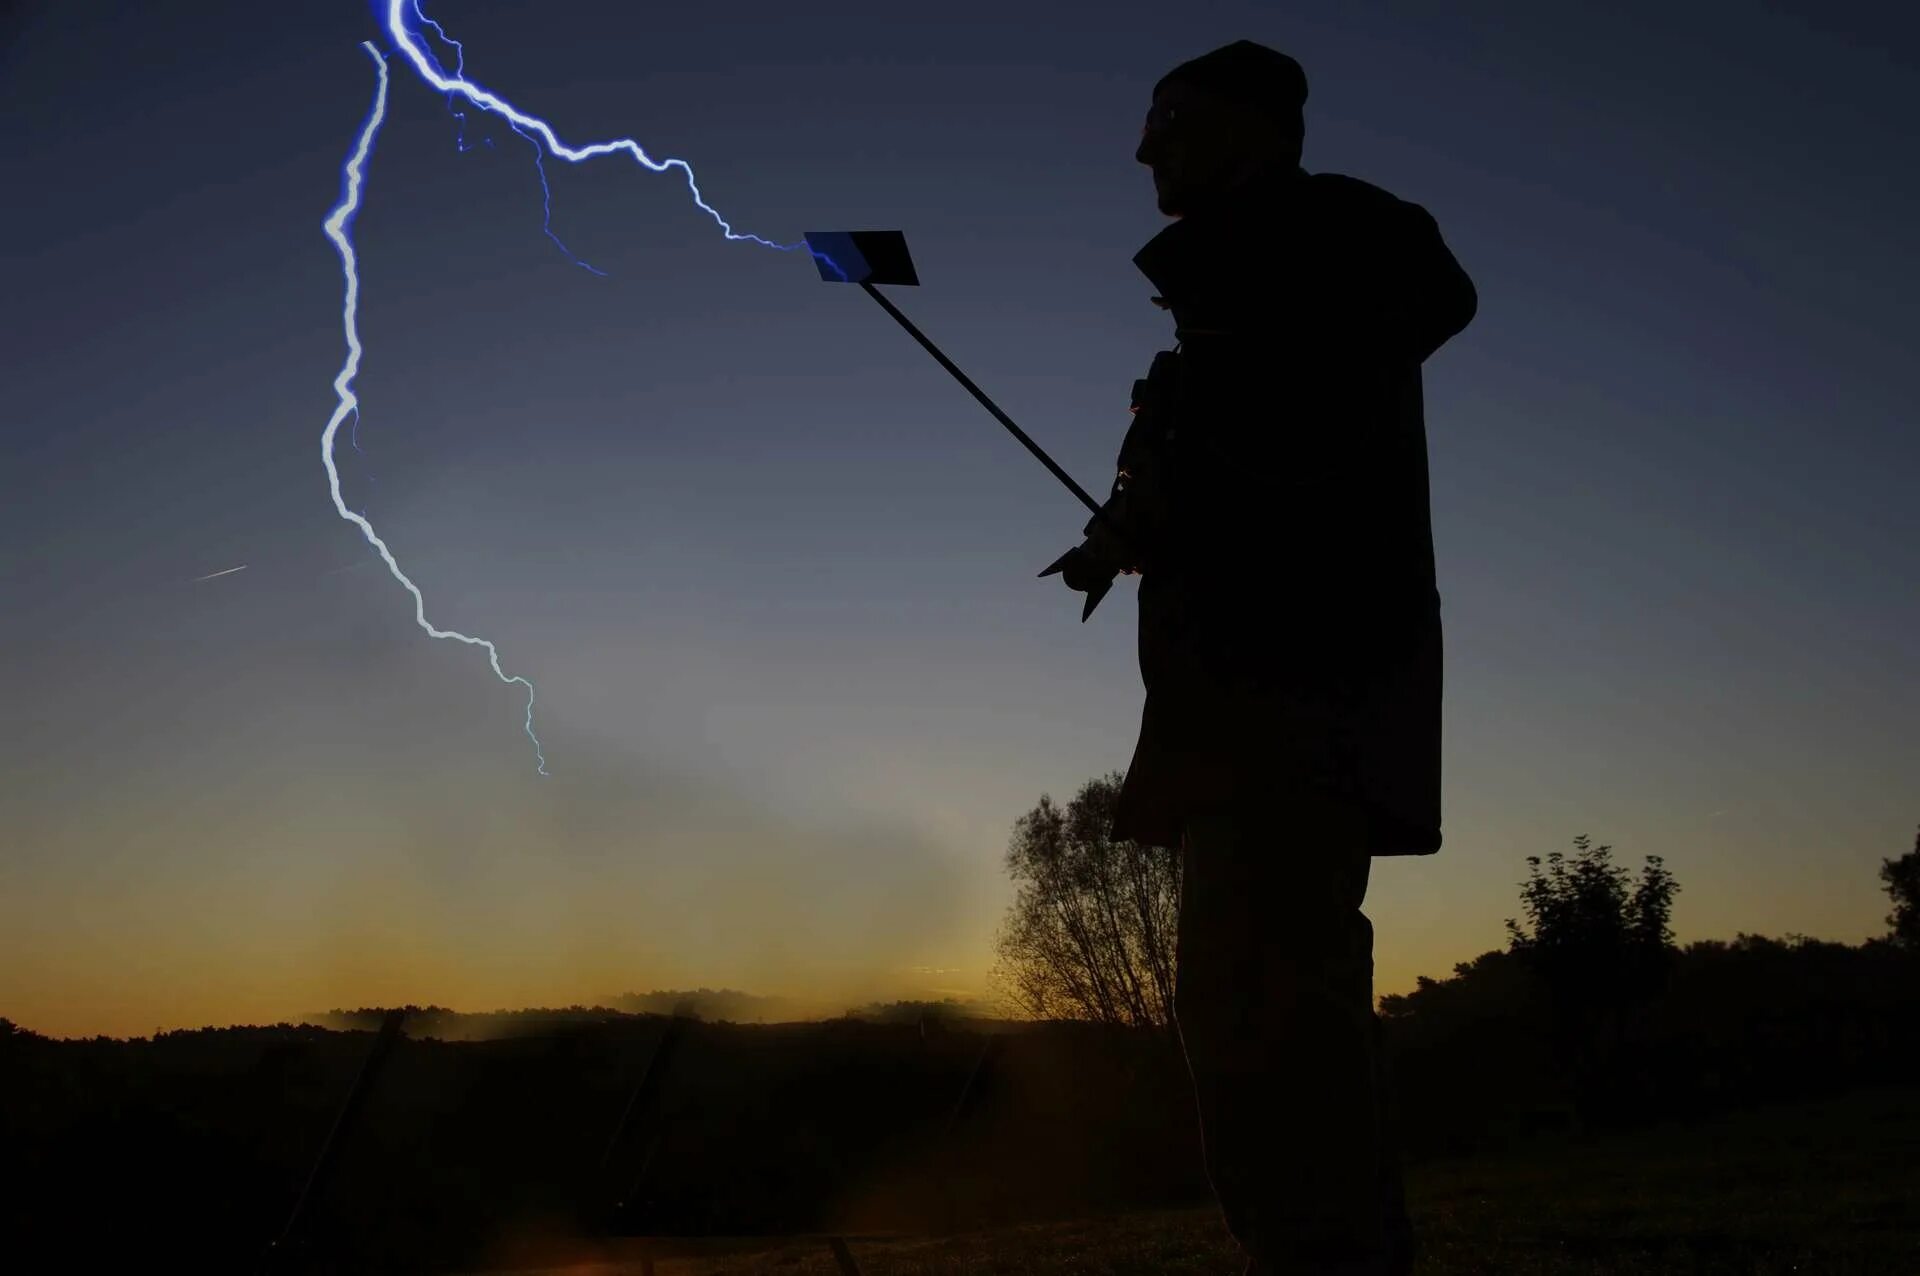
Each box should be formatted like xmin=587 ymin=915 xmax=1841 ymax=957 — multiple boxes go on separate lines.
xmin=0 ymin=1007 xmax=1206 ymax=1272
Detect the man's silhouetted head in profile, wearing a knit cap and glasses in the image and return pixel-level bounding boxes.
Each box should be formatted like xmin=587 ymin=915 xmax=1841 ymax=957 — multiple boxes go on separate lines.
xmin=1133 ymin=40 xmax=1308 ymax=217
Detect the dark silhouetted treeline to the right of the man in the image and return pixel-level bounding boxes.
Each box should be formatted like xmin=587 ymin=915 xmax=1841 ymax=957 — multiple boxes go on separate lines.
xmin=1380 ymin=934 xmax=1920 ymax=1157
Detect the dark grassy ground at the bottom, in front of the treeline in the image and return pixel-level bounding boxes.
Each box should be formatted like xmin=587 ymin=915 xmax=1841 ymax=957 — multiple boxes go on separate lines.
xmin=499 ymin=1090 xmax=1920 ymax=1276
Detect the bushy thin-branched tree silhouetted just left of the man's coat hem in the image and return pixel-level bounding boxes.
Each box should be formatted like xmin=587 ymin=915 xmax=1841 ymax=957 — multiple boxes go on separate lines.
xmin=995 ymin=773 xmax=1181 ymax=1030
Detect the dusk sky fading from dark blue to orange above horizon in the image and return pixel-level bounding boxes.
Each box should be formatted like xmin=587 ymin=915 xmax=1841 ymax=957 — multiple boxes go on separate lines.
xmin=0 ymin=0 xmax=1920 ymax=1034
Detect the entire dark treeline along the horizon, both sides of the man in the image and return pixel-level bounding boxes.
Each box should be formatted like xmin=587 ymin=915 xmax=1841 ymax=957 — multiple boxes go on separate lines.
xmin=0 ymin=934 xmax=1920 ymax=1272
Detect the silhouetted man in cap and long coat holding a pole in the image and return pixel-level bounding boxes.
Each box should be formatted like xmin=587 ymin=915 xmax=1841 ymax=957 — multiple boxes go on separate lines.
xmin=1048 ymin=40 xmax=1476 ymax=1276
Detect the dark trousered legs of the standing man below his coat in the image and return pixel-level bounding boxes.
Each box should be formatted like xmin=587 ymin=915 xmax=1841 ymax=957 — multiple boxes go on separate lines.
xmin=1175 ymin=802 xmax=1409 ymax=1276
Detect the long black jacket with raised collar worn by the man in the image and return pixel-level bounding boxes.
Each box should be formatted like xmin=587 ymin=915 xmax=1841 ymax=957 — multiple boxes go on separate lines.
xmin=1114 ymin=167 xmax=1476 ymax=856
